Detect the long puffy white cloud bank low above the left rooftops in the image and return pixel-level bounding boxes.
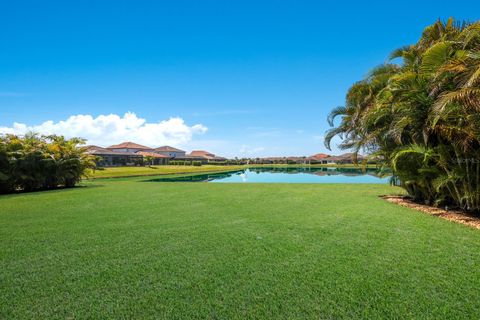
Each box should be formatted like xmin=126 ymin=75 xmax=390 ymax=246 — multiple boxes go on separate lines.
xmin=0 ymin=112 xmax=207 ymax=147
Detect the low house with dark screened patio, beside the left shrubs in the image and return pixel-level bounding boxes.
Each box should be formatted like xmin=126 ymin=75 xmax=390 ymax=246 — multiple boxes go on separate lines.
xmin=85 ymin=145 xmax=143 ymax=167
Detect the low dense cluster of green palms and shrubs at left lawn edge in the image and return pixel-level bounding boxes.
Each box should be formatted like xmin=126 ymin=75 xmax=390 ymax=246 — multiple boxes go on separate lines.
xmin=0 ymin=133 xmax=95 ymax=193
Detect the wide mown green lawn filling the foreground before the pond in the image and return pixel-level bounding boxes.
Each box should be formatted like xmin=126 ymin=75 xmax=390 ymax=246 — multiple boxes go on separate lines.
xmin=0 ymin=178 xmax=480 ymax=319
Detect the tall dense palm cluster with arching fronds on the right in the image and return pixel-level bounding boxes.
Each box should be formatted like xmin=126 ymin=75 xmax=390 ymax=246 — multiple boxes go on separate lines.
xmin=325 ymin=18 xmax=480 ymax=212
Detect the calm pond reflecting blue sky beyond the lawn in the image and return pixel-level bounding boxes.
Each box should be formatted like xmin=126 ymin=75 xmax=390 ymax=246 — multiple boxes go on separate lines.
xmin=149 ymin=167 xmax=389 ymax=184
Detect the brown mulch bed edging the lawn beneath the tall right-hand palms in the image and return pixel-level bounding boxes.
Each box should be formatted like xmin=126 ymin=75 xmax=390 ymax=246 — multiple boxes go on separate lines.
xmin=381 ymin=196 xmax=480 ymax=229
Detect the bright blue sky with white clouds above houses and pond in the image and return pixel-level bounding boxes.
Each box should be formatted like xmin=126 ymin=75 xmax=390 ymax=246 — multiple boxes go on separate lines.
xmin=0 ymin=1 xmax=480 ymax=157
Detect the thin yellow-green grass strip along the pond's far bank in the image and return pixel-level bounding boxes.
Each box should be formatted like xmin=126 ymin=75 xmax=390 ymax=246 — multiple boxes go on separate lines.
xmin=89 ymin=164 xmax=375 ymax=179
